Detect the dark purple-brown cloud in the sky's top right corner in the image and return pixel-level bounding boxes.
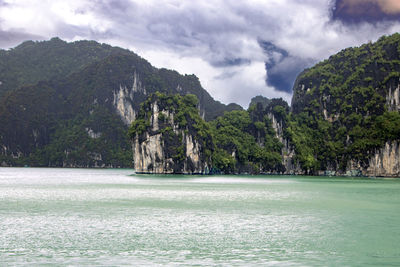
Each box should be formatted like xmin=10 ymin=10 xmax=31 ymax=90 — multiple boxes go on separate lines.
xmin=332 ymin=0 xmax=400 ymax=23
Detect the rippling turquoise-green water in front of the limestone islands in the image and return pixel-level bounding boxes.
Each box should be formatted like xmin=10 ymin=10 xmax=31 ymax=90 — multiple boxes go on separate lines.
xmin=0 ymin=168 xmax=400 ymax=266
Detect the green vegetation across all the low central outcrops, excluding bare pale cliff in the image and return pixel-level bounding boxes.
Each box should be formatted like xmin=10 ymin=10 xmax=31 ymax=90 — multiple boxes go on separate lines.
xmin=129 ymin=93 xmax=288 ymax=173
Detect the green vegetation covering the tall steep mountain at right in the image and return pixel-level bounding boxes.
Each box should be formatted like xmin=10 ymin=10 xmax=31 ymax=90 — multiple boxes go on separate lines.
xmin=286 ymin=34 xmax=400 ymax=173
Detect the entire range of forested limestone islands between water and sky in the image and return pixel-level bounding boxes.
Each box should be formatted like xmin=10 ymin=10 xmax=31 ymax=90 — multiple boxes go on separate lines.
xmin=0 ymin=34 xmax=400 ymax=177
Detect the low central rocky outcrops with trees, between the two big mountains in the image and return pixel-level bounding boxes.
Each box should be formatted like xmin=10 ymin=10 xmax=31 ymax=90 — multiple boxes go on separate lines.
xmin=130 ymin=93 xmax=289 ymax=174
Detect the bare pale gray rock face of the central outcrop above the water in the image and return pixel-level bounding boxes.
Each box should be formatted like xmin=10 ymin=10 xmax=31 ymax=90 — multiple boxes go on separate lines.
xmin=132 ymin=102 xmax=209 ymax=174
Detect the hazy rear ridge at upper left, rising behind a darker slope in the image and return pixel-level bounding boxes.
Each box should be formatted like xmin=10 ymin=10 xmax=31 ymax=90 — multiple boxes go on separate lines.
xmin=0 ymin=38 xmax=131 ymax=98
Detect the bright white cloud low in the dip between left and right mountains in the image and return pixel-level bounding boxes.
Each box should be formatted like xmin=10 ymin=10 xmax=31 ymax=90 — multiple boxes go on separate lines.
xmin=140 ymin=50 xmax=291 ymax=108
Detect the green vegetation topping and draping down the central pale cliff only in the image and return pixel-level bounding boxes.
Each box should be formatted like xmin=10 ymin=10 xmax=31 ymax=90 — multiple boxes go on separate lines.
xmin=129 ymin=92 xmax=213 ymax=172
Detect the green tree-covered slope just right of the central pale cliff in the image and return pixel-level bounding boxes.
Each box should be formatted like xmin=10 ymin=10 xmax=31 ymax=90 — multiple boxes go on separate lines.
xmin=211 ymin=104 xmax=284 ymax=173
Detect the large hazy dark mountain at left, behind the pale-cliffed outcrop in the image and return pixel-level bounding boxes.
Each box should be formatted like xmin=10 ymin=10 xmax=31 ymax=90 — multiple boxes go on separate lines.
xmin=0 ymin=38 xmax=241 ymax=167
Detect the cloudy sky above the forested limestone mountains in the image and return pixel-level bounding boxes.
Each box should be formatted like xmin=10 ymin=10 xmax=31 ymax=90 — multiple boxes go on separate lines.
xmin=0 ymin=0 xmax=400 ymax=107
